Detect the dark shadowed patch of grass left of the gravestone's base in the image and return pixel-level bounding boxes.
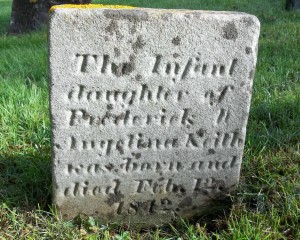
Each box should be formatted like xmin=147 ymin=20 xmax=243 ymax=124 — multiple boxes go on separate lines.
xmin=0 ymin=151 xmax=51 ymax=210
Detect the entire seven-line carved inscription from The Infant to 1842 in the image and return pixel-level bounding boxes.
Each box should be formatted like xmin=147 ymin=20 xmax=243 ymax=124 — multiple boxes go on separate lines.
xmin=63 ymin=48 xmax=243 ymax=215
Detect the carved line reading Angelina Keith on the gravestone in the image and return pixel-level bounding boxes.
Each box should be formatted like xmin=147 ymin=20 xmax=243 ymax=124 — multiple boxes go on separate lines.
xmin=68 ymin=129 xmax=243 ymax=156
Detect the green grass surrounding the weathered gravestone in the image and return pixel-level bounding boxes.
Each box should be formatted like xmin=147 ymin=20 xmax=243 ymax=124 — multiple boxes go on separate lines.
xmin=0 ymin=0 xmax=300 ymax=239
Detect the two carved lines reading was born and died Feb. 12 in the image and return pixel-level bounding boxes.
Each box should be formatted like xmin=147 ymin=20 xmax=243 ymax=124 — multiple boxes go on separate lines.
xmin=64 ymin=156 xmax=238 ymax=200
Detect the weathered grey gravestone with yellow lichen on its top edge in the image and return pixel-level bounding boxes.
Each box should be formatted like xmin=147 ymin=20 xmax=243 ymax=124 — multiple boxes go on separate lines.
xmin=49 ymin=5 xmax=259 ymax=224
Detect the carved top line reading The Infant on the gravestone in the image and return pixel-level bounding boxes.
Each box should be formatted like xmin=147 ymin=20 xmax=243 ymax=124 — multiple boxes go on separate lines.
xmin=75 ymin=53 xmax=238 ymax=82
